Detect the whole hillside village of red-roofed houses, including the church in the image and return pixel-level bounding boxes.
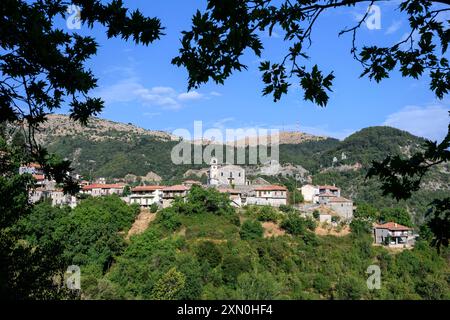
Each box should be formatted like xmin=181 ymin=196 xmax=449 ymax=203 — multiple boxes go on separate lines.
xmin=19 ymin=158 xmax=416 ymax=247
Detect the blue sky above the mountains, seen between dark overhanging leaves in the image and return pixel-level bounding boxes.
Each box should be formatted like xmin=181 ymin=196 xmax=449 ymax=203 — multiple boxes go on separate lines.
xmin=61 ymin=0 xmax=450 ymax=139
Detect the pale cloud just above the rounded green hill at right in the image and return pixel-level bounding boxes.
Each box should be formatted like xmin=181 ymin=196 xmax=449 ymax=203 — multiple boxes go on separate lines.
xmin=383 ymin=105 xmax=450 ymax=141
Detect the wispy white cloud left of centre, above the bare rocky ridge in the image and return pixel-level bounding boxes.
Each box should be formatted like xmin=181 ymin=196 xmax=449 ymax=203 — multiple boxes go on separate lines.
xmin=95 ymin=77 xmax=210 ymax=109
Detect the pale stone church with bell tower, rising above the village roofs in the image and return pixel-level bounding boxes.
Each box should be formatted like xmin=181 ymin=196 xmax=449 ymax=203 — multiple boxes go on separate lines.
xmin=208 ymin=157 xmax=247 ymax=186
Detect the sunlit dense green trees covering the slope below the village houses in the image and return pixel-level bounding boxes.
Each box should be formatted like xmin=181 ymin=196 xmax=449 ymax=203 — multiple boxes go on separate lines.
xmin=15 ymin=188 xmax=450 ymax=299
